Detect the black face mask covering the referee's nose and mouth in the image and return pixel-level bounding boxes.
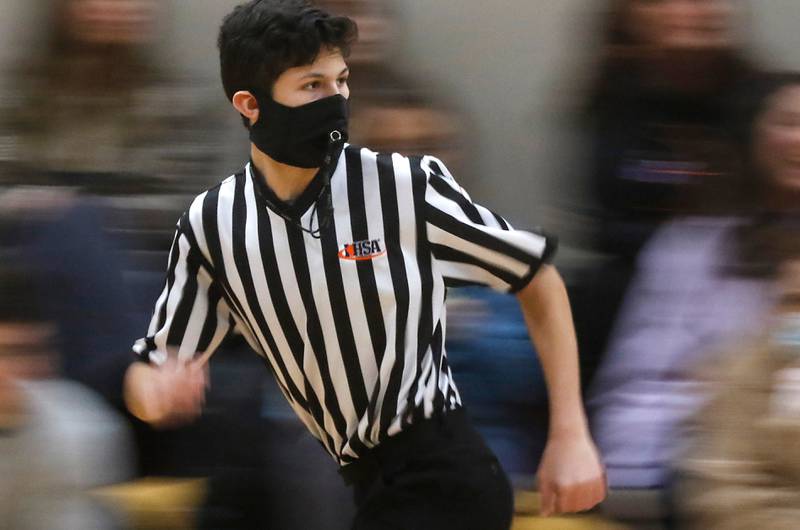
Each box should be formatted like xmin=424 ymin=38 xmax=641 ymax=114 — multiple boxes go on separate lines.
xmin=250 ymin=90 xmax=349 ymax=168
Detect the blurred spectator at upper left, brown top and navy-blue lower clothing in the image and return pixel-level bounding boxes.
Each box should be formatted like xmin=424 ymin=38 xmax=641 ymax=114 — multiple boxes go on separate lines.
xmin=0 ymin=0 xmax=212 ymax=424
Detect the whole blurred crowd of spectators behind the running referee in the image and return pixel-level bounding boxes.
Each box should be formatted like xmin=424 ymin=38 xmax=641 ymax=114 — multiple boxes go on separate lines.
xmin=0 ymin=0 xmax=800 ymax=530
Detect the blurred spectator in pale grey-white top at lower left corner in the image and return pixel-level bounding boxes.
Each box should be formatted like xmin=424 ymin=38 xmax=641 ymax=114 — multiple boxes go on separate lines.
xmin=0 ymin=262 xmax=131 ymax=530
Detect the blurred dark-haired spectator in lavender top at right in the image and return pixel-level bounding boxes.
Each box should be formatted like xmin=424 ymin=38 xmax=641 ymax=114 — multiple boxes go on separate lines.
xmin=588 ymin=74 xmax=800 ymax=520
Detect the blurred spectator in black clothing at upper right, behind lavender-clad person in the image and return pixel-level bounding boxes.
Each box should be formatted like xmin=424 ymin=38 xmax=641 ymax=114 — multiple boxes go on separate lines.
xmin=571 ymin=0 xmax=753 ymax=380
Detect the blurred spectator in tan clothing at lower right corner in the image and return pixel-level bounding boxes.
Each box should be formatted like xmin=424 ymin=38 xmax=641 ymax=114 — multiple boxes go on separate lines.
xmin=676 ymin=245 xmax=800 ymax=530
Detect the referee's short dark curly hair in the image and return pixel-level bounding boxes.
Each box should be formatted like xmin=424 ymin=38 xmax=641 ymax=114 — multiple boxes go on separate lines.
xmin=217 ymin=0 xmax=358 ymax=126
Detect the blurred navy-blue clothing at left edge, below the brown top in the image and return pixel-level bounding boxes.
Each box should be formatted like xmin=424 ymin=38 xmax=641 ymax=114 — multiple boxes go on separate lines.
xmin=0 ymin=187 xmax=135 ymax=409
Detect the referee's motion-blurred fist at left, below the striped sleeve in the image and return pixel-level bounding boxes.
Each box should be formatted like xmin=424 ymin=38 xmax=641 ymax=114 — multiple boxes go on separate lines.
xmin=124 ymin=360 xmax=208 ymax=428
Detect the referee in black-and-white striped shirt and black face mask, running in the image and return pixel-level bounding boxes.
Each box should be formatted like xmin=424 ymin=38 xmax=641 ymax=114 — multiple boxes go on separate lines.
xmin=133 ymin=0 xmax=605 ymax=530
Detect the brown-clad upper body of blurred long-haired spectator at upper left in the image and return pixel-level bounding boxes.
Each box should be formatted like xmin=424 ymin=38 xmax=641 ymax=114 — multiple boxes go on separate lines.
xmin=0 ymin=0 xmax=230 ymax=194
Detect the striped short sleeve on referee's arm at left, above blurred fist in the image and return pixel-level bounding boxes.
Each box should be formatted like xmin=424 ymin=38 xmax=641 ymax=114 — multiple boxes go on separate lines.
xmin=133 ymin=212 xmax=233 ymax=364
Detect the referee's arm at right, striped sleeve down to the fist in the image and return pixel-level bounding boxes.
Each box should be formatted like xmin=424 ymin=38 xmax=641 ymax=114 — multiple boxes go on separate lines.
xmin=421 ymin=157 xmax=606 ymax=515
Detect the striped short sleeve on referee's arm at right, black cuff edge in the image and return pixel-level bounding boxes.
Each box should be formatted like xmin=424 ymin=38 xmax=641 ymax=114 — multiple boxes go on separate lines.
xmin=421 ymin=156 xmax=557 ymax=293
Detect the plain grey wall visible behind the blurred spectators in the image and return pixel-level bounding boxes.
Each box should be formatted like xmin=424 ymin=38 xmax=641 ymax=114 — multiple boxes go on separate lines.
xmin=0 ymin=0 xmax=800 ymax=221
